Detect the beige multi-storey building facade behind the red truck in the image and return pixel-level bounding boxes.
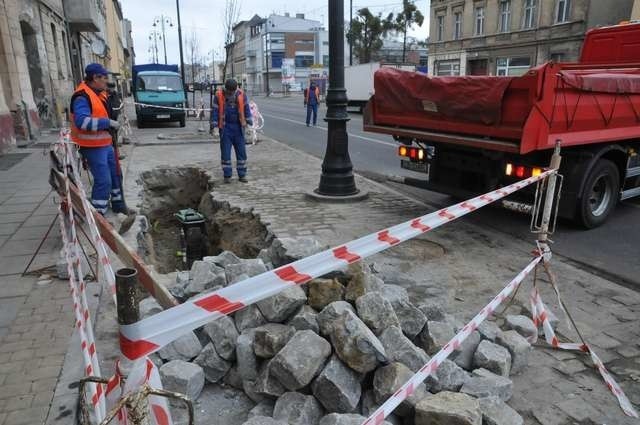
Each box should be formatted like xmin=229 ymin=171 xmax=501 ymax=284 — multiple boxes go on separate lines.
xmin=429 ymin=0 xmax=633 ymax=75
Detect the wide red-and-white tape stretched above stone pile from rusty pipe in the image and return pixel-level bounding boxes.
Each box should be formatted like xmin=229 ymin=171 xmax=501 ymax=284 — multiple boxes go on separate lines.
xmin=120 ymin=171 xmax=555 ymax=360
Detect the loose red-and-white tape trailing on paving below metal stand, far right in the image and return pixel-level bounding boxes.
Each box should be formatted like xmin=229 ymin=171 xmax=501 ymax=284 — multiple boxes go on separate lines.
xmin=530 ymin=285 xmax=638 ymax=418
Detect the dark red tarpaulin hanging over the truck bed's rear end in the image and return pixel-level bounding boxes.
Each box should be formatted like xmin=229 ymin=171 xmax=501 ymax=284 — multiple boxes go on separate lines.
xmin=374 ymin=68 xmax=513 ymax=125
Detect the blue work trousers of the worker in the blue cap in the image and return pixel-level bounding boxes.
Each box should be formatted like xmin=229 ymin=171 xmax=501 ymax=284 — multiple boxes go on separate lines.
xmin=80 ymin=145 xmax=126 ymax=215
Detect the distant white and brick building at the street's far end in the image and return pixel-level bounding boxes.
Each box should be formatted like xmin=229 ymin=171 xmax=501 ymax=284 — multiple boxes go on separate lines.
xmin=227 ymin=13 xmax=329 ymax=93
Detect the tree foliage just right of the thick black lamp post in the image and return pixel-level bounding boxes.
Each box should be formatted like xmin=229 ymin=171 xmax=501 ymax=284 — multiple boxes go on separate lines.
xmin=347 ymin=7 xmax=395 ymax=63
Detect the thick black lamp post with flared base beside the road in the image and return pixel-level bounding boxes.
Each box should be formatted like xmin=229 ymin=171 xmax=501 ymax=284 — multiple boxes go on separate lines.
xmin=314 ymin=0 xmax=360 ymax=198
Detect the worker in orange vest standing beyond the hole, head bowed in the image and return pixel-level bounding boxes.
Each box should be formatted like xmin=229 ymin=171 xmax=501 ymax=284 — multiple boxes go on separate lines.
xmin=211 ymin=79 xmax=252 ymax=183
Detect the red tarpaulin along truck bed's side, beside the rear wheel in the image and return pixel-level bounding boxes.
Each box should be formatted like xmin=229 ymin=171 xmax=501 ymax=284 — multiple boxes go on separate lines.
xmin=560 ymin=68 xmax=640 ymax=94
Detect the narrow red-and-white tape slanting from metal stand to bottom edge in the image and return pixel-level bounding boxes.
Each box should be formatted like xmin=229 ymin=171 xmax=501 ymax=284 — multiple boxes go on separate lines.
xmin=363 ymin=256 xmax=542 ymax=425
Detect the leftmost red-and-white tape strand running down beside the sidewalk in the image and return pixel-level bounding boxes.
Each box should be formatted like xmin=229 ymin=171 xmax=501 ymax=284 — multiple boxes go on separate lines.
xmin=58 ymin=146 xmax=105 ymax=419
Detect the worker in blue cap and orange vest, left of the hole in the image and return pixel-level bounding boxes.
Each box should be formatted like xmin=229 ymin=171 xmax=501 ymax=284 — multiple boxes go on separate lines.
xmin=71 ymin=63 xmax=130 ymax=215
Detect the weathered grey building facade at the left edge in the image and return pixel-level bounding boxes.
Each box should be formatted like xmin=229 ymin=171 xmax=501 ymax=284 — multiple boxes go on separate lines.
xmin=0 ymin=0 xmax=78 ymax=153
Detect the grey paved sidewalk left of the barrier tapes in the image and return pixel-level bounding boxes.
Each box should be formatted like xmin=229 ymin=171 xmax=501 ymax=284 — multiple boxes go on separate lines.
xmin=0 ymin=137 xmax=73 ymax=425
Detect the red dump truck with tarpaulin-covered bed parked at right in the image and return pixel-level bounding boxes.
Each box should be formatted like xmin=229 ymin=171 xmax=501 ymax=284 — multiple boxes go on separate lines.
xmin=363 ymin=23 xmax=640 ymax=228
